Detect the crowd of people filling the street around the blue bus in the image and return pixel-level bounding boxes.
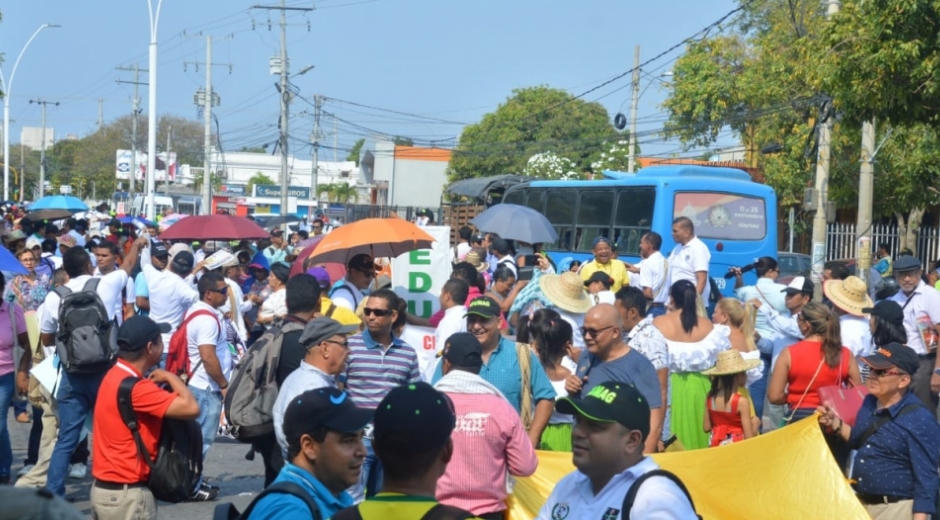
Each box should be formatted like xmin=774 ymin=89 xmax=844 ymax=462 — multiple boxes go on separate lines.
xmin=0 ymin=208 xmax=940 ymax=520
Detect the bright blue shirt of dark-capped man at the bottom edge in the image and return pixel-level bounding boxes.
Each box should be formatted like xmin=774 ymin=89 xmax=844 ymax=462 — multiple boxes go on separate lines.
xmin=248 ymin=463 xmax=353 ymax=520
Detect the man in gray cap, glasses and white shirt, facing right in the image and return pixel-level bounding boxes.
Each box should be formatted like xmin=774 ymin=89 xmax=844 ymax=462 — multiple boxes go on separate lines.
xmin=272 ymin=317 xmax=359 ymax=460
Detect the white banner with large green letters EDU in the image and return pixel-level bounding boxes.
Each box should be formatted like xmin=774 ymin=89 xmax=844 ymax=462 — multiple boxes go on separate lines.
xmin=392 ymin=226 xmax=452 ymax=318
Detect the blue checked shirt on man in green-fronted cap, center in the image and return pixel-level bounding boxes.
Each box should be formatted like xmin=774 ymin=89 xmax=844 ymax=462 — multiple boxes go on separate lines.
xmin=432 ymin=336 xmax=555 ymax=412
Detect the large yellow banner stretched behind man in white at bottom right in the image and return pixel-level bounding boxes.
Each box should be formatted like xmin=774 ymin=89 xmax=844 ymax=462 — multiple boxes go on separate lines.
xmin=509 ymin=416 xmax=869 ymax=520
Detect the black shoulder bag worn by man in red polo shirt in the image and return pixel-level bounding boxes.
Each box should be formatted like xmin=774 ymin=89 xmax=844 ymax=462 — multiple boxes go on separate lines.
xmin=118 ymin=376 xmax=202 ymax=503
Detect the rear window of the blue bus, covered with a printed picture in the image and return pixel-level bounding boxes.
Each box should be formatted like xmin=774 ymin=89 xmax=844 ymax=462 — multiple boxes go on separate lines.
xmin=673 ymin=191 xmax=767 ymax=240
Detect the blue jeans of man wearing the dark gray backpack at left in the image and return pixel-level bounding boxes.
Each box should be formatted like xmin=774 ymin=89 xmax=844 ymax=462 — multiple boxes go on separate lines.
xmin=46 ymin=370 xmax=107 ymax=496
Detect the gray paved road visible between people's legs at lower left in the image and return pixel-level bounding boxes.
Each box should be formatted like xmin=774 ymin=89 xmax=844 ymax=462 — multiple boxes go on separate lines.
xmin=7 ymin=410 xmax=264 ymax=520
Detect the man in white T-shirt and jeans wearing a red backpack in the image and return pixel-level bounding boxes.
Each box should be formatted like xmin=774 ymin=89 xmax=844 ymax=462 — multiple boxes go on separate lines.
xmin=184 ymin=272 xmax=234 ymax=500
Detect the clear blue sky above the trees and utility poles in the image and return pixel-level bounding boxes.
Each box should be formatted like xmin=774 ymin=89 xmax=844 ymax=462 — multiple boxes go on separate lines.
xmin=0 ymin=0 xmax=737 ymax=160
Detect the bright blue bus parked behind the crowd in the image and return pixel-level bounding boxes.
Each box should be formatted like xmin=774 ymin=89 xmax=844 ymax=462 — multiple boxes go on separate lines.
xmin=503 ymin=165 xmax=777 ymax=296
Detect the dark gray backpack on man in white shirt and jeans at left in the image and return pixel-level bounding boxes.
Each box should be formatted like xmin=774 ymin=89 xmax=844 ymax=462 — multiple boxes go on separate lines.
xmin=55 ymin=278 xmax=117 ymax=374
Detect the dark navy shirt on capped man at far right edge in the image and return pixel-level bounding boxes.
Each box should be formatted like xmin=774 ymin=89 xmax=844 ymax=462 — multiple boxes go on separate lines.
xmin=848 ymin=391 xmax=940 ymax=515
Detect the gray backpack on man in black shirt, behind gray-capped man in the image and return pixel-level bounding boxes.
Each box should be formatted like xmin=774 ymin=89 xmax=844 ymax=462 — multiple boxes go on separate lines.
xmin=223 ymin=321 xmax=304 ymax=442
